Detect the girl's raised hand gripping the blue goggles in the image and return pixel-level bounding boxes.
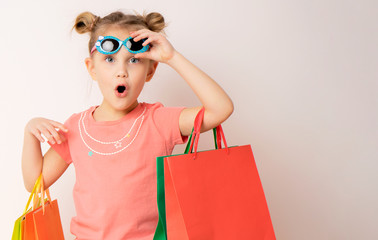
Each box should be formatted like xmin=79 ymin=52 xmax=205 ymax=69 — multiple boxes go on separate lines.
xmin=130 ymin=29 xmax=176 ymax=63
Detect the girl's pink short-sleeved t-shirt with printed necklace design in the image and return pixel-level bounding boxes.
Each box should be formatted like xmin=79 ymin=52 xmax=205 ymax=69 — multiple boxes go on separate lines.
xmin=50 ymin=103 xmax=187 ymax=240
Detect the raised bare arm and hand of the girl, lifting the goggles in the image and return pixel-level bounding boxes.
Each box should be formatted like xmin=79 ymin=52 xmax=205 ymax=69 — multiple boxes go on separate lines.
xmin=130 ymin=29 xmax=234 ymax=136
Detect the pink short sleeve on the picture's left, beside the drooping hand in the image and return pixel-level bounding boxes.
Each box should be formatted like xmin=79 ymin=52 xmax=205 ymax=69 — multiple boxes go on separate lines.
xmin=47 ymin=114 xmax=75 ymax=164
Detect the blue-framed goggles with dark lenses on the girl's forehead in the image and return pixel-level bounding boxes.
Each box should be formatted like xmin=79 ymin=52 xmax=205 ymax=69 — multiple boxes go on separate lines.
xmin=91 ymin=36 xmax=149 ymax=54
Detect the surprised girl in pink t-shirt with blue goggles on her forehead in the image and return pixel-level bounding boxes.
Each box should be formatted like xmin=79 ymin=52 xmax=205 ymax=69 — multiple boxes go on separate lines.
xmin=22 ymin=12 xmax=233 ymax=240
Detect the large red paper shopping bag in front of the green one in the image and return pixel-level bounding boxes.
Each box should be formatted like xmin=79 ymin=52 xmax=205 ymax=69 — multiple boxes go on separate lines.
xmin=164 ymin=109 xmax=275 ymax=240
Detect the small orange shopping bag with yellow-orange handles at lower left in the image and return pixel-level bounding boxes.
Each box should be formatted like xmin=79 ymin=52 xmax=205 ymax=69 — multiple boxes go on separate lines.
xmin=13 ymin=174 xmax=64 ymax=240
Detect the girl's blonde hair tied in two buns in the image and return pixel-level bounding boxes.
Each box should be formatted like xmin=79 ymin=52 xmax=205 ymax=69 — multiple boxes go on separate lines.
xmin=71 ymin=11 xmax=166 ymax=53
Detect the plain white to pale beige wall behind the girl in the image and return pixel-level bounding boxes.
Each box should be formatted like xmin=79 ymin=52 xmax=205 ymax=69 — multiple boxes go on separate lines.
xmin=0 ymin=0 xmax=378 ymax=240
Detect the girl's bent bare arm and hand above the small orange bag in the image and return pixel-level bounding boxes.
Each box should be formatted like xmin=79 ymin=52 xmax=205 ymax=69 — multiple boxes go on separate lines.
xmin=22 ymin=118 xmax=69 ymax=192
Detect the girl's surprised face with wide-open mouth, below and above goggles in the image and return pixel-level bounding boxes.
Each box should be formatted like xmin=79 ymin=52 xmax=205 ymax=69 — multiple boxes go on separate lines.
xmin=85 ymin=24 xmax=157 ymax=112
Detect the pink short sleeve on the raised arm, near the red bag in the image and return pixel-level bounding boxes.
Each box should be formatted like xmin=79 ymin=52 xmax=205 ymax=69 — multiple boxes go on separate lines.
xmin=153 ymin=104 xmax=188 ymax=146
